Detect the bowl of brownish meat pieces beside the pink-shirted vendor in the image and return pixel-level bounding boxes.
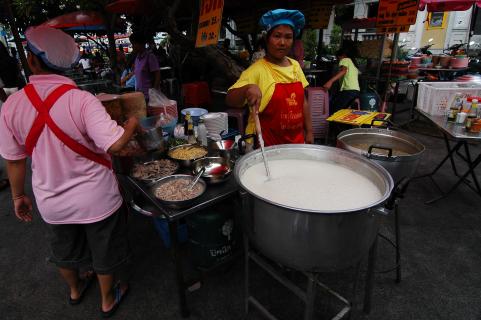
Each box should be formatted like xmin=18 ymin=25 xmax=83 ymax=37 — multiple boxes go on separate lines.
xmin=130 ymin=159 xmax=179 ymax=183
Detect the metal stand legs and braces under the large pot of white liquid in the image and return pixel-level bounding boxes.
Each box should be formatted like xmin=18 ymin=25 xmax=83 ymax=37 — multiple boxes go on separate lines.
xmin=244 ymin=235 xmax=368 ymax=320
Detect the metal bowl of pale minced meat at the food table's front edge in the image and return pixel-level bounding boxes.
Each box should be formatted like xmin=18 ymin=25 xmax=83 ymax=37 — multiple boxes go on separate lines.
xmin=151 ymin=174 xmax=207 ymax=209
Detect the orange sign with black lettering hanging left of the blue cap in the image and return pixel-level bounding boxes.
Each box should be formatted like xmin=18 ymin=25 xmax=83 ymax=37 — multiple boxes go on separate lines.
xmin=195 ymin=0 xmax=224 ymax=48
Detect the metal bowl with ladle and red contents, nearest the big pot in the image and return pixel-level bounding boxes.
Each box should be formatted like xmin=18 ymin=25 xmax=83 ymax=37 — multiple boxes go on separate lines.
xmin=192 ymin=157 xmax=233 ymax=184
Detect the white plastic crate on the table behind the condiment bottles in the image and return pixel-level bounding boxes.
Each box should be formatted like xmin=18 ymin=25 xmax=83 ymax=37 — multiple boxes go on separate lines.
xmin=417 ymin=82 xmax=481 ymax=116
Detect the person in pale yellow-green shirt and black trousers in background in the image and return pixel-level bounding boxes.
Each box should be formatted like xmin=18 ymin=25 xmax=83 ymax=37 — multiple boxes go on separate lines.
xmin=323 ymin=48 xmax=360 ymax=114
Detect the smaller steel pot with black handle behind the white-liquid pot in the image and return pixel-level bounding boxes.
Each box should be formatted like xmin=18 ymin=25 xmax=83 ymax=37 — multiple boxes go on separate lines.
xmin=337 ymin=128 xmax=425 ymax=182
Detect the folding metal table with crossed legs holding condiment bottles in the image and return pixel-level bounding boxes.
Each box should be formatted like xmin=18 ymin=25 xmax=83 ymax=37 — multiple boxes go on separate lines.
xmin=415 ymin=108 xmax=481 ymax=204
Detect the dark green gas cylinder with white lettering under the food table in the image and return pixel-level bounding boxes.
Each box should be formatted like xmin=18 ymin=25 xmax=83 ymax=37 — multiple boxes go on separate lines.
xmin=186 ymin=205 xmax=236 ymax=268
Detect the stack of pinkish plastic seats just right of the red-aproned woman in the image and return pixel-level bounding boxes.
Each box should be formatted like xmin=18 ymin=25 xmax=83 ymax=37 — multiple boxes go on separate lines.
xmin=307 ymin=88 xmax=329 ymax=139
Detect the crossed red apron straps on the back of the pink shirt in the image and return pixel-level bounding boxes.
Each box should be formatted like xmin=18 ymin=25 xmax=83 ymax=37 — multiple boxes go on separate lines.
xmin=24 ymin=84 xmax=112 ymax=169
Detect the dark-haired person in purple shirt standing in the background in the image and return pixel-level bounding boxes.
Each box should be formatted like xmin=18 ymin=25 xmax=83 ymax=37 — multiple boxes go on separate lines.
xmin=129 ymin=33 xmax=160 ymax=101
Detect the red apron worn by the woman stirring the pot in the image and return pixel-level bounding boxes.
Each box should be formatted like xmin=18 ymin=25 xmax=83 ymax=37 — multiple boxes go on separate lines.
xmin=259 ymin=62 xmax=304 ymax=146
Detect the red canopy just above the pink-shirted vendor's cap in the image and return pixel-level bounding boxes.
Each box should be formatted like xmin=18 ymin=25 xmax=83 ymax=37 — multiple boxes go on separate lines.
xmin=42 ymin=11 xmax=105 ymax=31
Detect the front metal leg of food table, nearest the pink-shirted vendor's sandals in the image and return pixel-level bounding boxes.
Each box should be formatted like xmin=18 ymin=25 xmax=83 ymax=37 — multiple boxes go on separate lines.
xmin=169 ymin=220 xmax=190 ymax=318
